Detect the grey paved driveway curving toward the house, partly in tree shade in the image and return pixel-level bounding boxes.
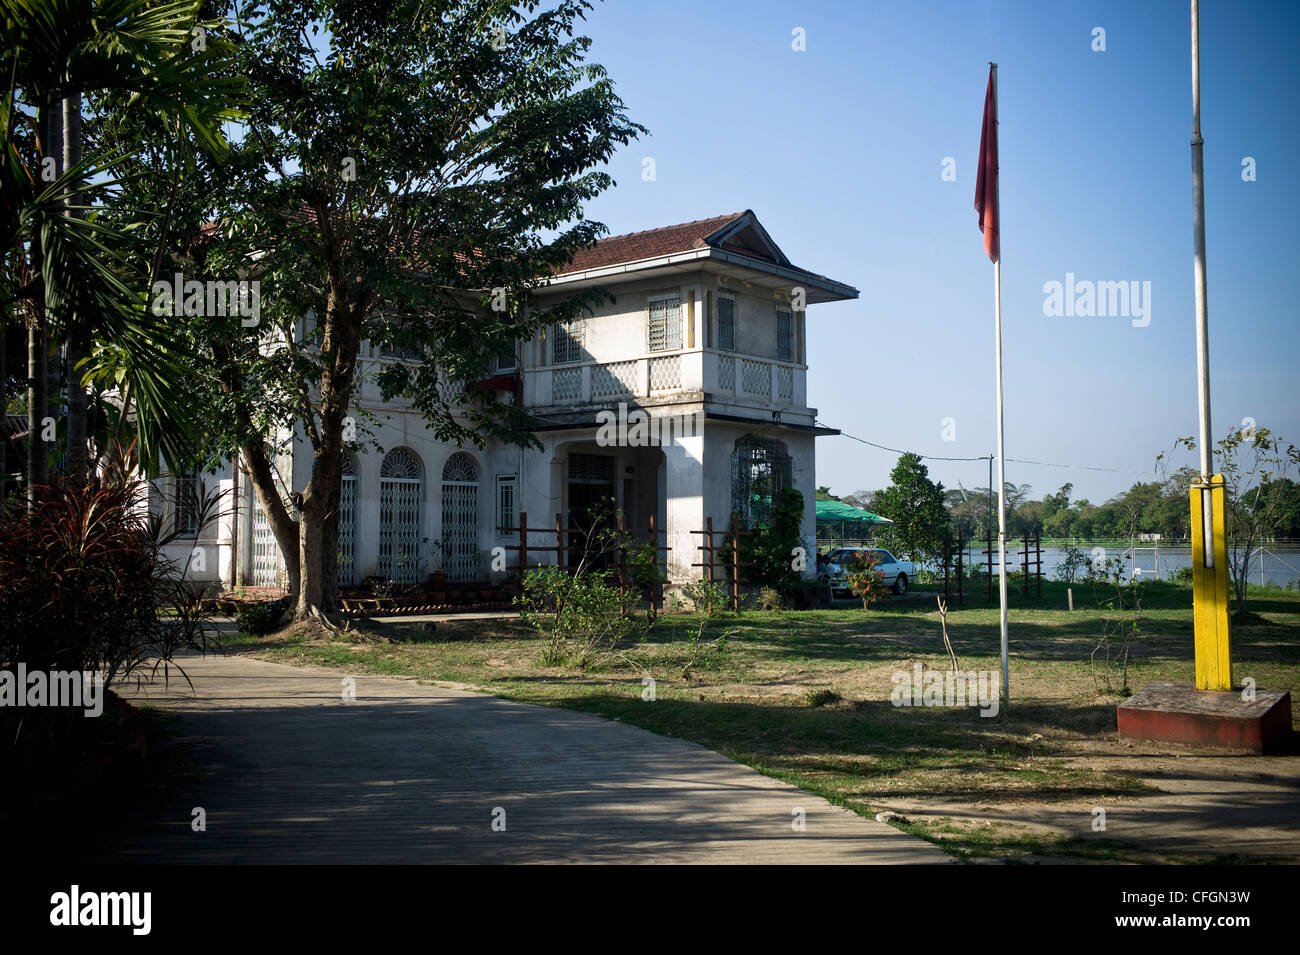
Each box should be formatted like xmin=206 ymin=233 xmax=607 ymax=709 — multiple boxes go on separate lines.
xmin=92 ymin=656 xmax=945 ymax=863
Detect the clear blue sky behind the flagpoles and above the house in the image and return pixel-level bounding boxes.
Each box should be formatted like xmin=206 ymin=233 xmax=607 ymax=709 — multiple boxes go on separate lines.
xmin=574 ymin=0 xmax=1300 ymax=503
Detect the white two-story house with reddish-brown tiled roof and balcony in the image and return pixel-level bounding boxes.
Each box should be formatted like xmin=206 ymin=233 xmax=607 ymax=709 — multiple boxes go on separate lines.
xmin=159 ymin=210 xmax=858 ymax=587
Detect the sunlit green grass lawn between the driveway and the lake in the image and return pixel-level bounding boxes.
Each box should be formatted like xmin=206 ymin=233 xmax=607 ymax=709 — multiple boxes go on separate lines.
xmin=234 ymin=574 xmax=1300 ymax=861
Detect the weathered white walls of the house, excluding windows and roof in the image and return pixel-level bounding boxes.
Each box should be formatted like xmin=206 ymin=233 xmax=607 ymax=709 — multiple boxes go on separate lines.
xmin=184 ymin=263 xmax=815 ymax=582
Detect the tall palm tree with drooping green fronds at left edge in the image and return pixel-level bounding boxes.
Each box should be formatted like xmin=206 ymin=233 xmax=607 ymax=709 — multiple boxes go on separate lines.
xmin=0 ymin=0 xmax=242 ymax=494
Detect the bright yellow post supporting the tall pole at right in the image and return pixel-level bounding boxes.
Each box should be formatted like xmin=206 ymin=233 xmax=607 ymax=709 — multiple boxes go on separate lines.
xmin=1191 ymin=474 xmax=1232 ymax=690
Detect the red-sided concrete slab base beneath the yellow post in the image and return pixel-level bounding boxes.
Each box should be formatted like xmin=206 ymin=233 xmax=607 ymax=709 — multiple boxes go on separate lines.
xmin=1117 ymin=683 xmax=1291 ymax=754
